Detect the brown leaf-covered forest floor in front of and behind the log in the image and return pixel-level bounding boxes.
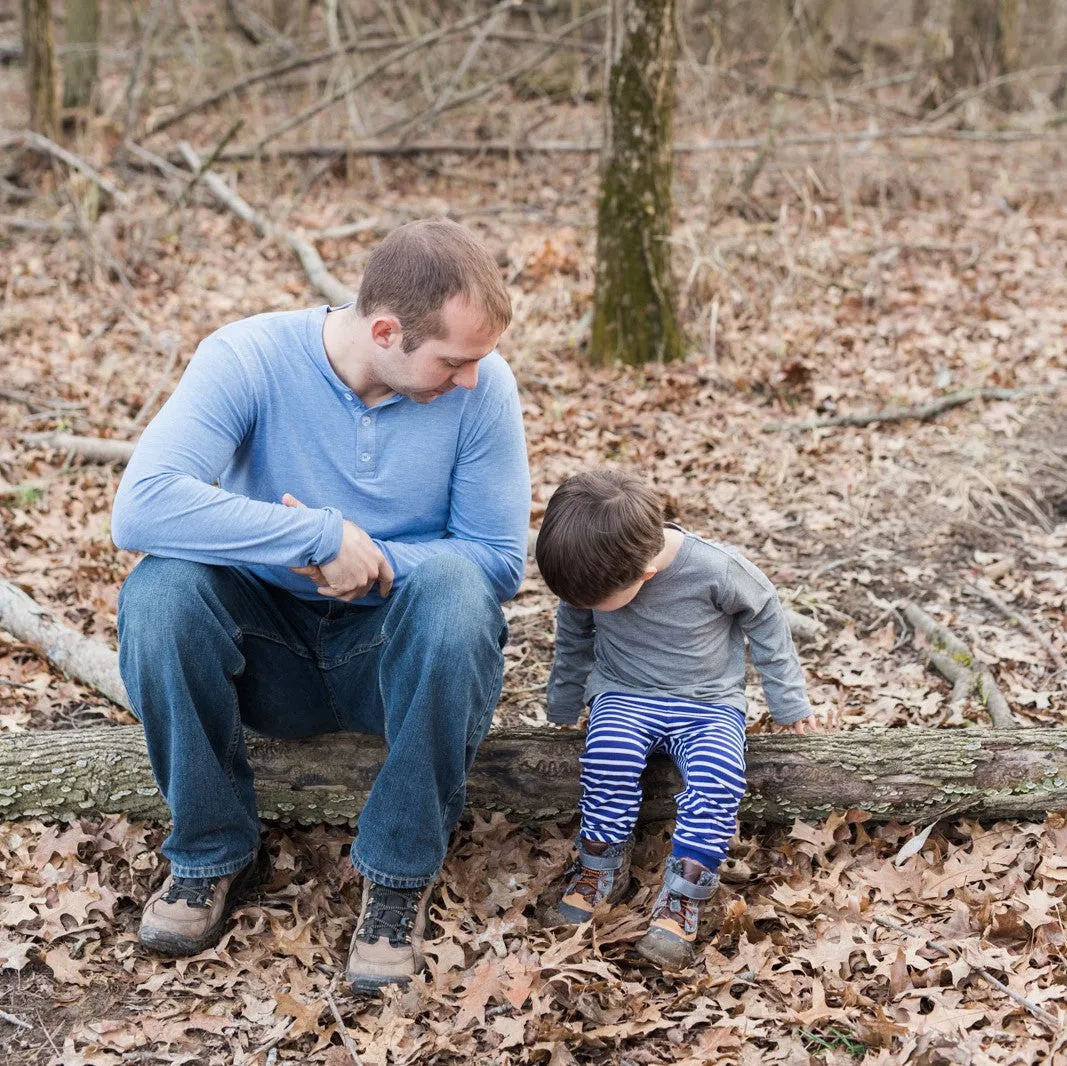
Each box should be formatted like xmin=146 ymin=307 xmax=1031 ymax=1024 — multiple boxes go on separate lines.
xmin=0 ymin=12 xmax=1067 ymax=1066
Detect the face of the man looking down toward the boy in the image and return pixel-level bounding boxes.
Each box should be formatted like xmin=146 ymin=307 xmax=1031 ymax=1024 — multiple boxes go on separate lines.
xmin=377 ymin=297 xmax=499 ymax=403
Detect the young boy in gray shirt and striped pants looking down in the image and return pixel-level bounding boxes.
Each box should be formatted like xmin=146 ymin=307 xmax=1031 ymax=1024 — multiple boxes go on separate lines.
xmin=537 ymin=470 xmax=815 ymax=969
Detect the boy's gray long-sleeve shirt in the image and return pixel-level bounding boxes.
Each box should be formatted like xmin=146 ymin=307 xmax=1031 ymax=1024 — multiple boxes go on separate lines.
xmin=547 ymin=532 xmax=812 ymax=725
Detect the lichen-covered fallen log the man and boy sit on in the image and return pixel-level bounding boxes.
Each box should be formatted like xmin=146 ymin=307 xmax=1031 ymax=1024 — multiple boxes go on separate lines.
xmin=0 ymin=726 xmax=1067 ymax=825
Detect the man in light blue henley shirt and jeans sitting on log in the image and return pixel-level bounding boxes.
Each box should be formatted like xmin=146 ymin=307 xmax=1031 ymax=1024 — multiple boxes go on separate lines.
xmin=112 ymin=220 xmax=529 ymax=991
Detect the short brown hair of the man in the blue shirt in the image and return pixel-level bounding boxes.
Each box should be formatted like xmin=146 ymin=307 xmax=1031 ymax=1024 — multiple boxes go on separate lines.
xmin=355 ymin=219 xmax=511 ymax=352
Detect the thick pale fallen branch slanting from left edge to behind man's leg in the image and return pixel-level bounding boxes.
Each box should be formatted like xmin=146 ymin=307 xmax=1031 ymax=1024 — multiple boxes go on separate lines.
xmin=0 ymin=578 xmax=129 ymax=712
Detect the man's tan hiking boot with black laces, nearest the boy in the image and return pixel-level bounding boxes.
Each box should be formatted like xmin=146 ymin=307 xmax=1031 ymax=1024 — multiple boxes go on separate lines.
xmin=345 ymin=877 xmax=433 ymax=992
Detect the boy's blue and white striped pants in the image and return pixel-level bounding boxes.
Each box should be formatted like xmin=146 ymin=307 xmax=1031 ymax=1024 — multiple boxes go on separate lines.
xmin=580 ymin=693 xmax=745 ymax=870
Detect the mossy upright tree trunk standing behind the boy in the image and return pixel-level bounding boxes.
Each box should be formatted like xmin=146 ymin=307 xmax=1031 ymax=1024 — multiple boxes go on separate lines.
xmin=589 ymin=0 xmax=682 ymax=364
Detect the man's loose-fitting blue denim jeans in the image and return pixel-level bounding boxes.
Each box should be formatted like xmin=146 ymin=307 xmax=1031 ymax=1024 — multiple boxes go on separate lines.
xmin=118 ymin=555 xmax=507 ymax=888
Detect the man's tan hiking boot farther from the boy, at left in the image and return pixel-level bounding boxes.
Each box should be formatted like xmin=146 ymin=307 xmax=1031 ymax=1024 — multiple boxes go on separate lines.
xmin=138 ymin=845 xmax=270 ymax=957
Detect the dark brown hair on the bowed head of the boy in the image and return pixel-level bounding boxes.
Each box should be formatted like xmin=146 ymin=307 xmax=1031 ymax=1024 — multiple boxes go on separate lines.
xmin=536 ymin=470 xmax=665 ymax=607
